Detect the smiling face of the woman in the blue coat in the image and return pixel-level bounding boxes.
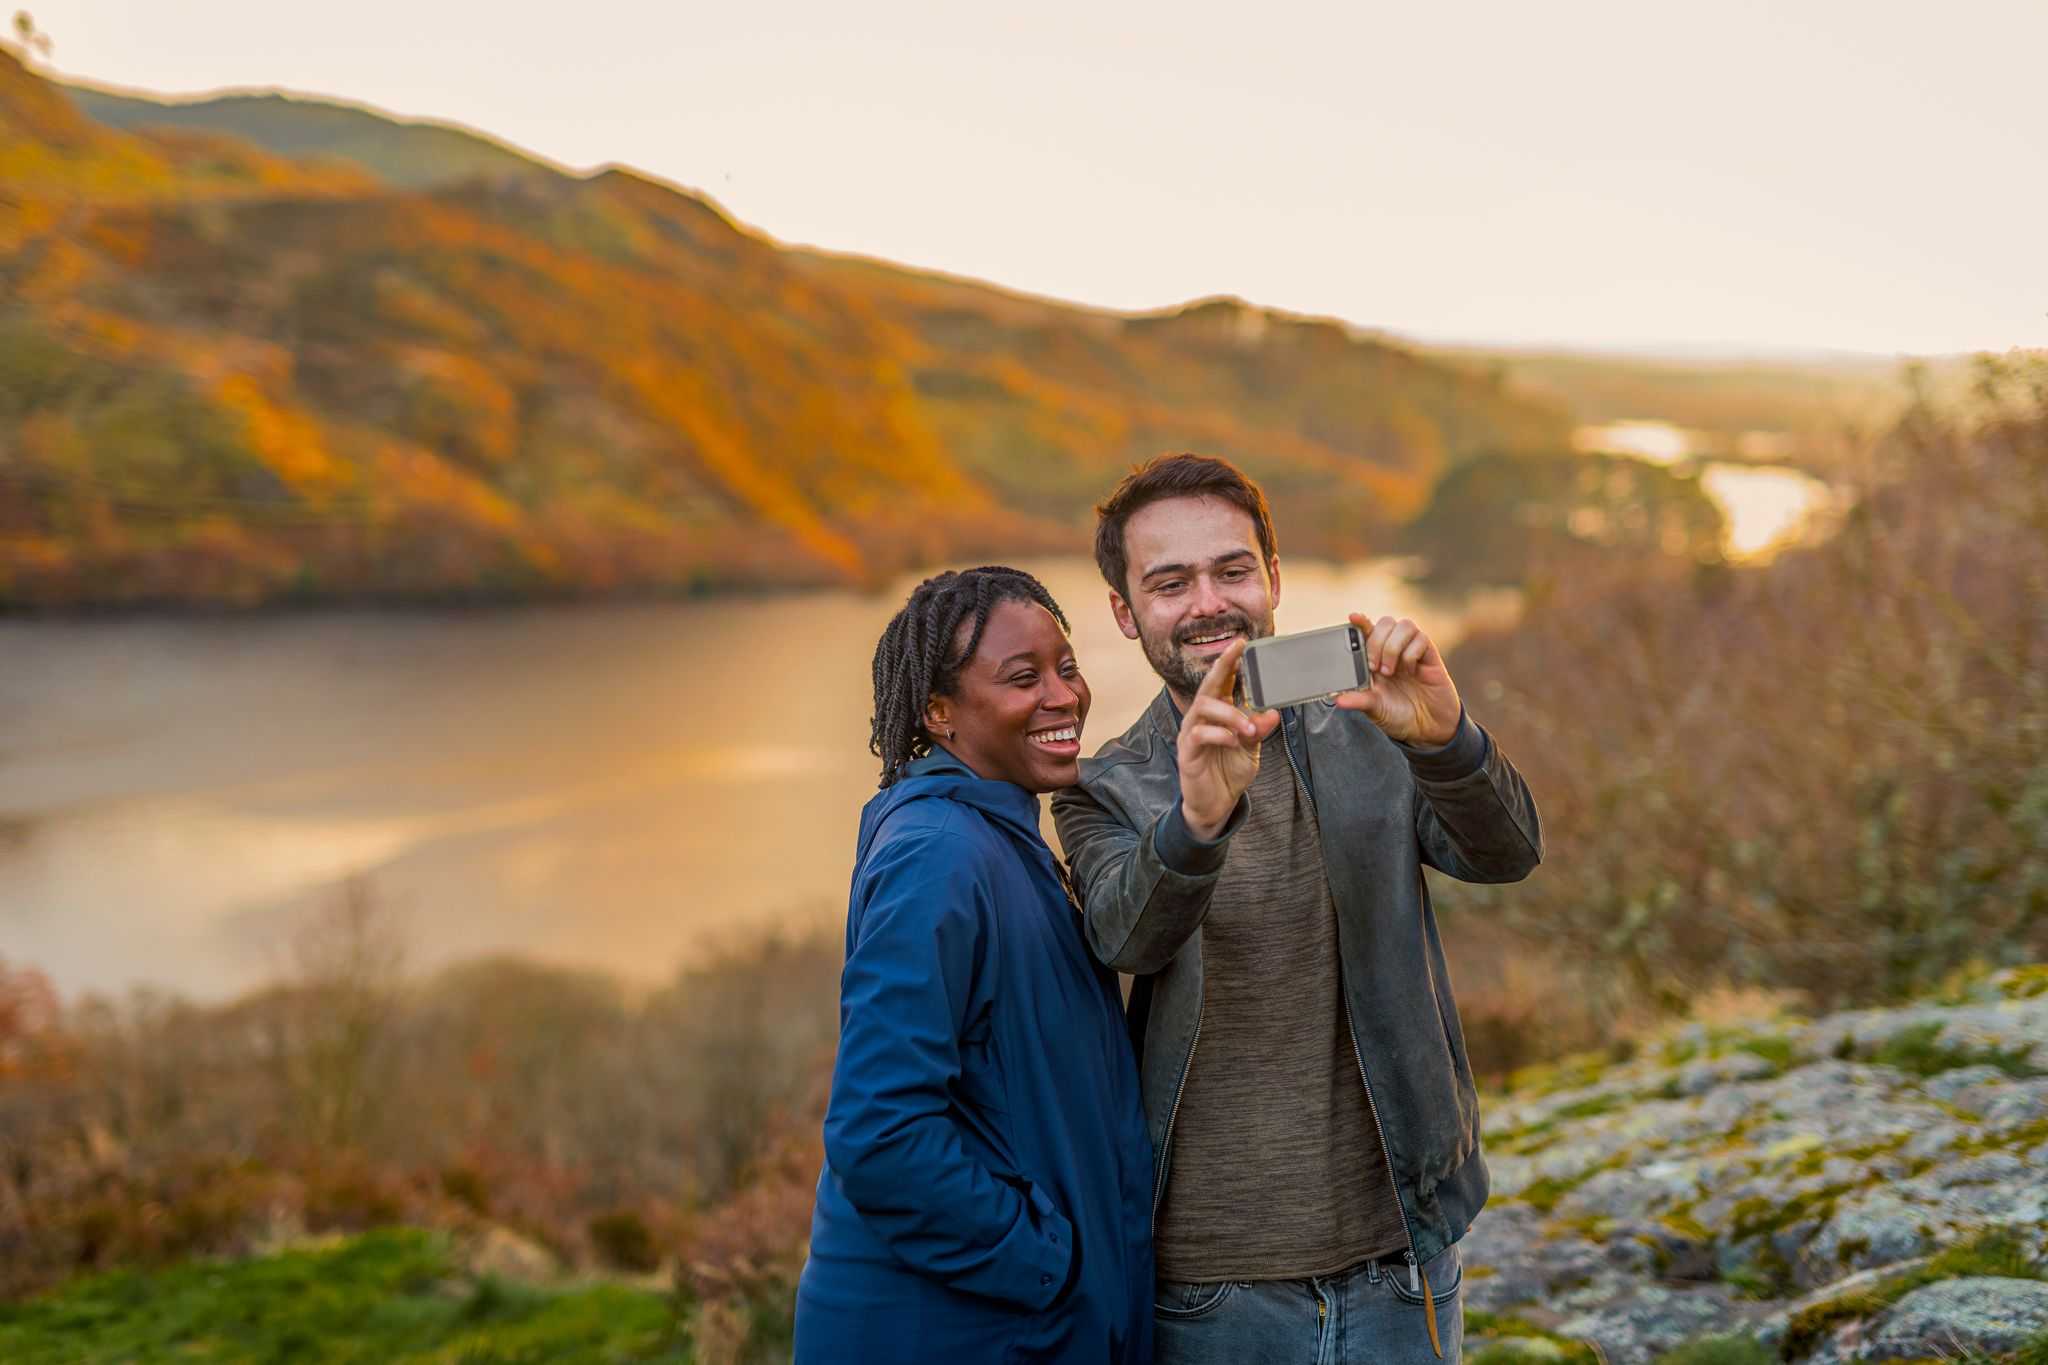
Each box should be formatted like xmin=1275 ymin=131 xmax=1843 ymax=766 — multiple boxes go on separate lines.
xmin=926 ymin=602 xmax=1087 ymax=792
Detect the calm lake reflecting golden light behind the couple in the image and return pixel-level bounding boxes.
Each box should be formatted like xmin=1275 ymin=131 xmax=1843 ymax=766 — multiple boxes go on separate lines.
xmin=0 ymin=559 xmax=1507 ymax=999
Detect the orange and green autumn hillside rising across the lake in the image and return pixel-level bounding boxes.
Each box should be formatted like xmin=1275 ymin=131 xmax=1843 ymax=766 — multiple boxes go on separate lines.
xmin=0 ymin=55 xmax=1569 ymax=608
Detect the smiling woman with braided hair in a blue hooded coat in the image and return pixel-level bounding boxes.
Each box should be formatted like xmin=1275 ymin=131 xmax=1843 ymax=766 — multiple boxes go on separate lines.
xmin=797 ymin=569 xmax=1153 ymax=1365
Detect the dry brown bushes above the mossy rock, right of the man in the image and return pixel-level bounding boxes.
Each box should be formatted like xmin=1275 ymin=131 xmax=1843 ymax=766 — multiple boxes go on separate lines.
xmin=1438 ymin=356 xmax=2048 ymax=1044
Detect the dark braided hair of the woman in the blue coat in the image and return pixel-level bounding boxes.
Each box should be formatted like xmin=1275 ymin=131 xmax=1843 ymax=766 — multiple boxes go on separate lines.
xmin=868 ymin=565 xmax=1069 ymax=786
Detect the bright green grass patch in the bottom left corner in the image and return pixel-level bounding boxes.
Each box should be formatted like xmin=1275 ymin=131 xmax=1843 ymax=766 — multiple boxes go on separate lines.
xmin=0 ymin=1228 xmax=690 ymax=1365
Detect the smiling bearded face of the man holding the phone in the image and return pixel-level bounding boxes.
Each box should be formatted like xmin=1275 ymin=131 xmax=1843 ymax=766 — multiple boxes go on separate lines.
xmin=1110 ymin=497 xmax=1280 ymax=706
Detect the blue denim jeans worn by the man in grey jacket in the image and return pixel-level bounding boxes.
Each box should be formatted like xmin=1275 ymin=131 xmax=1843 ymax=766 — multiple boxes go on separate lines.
xmin=1153 ymin=1244 xmax=1464 ymax=1365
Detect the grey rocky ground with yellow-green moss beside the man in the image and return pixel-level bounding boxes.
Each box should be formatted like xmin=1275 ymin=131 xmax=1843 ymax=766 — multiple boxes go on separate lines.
xmin=1464 ymin=966 xmax=2048 ymax=1365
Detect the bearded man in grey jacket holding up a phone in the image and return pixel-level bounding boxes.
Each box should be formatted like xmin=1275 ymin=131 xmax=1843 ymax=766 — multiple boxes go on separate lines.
xmin=1053 ymin=454 xmax=1542 ymax=1365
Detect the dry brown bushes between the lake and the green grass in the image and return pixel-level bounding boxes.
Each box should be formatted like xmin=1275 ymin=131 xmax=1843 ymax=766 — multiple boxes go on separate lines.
xmin=0 ymin=884 xmax=840 ymax=1295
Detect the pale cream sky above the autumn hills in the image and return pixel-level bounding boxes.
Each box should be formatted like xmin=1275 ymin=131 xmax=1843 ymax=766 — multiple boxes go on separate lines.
xmin=28 ymin=0 xmax=2048 ymax=354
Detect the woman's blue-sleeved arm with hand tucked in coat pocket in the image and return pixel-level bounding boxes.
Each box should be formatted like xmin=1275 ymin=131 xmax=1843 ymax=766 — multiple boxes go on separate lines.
xmin=825 ymin=831 xmax=1073 ymax=1312
